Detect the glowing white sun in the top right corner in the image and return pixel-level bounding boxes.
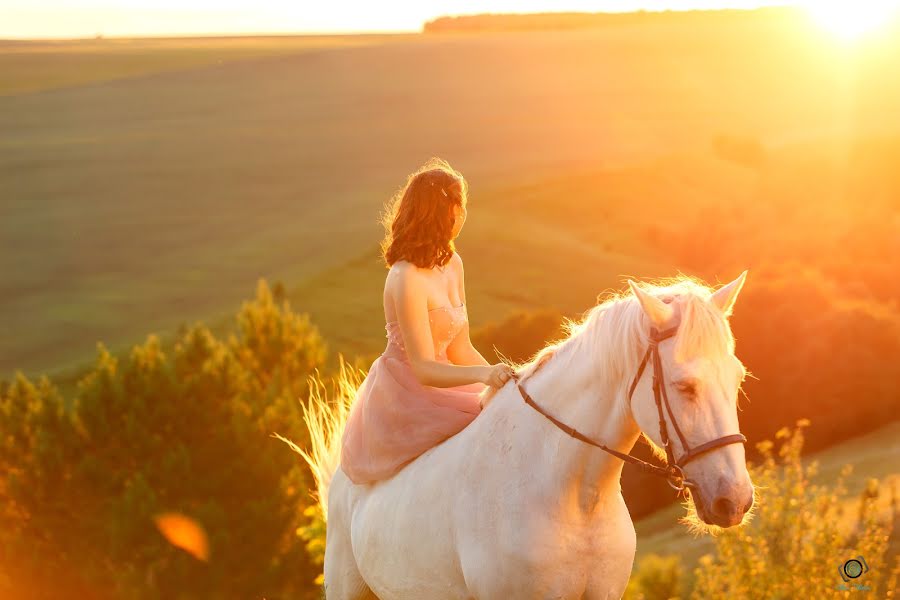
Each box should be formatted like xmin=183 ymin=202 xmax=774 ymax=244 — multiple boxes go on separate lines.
xmin=801 ymin=0 xmax=900 ymax=41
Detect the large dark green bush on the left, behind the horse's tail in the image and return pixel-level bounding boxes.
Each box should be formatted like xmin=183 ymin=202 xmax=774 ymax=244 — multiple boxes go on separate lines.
xmin=0 ymin=280 xmax=325 ymax=599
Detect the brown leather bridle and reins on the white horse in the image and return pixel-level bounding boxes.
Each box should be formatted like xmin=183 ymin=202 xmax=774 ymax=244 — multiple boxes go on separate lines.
xmin=515 ymin=326 xmax=747 ymax=491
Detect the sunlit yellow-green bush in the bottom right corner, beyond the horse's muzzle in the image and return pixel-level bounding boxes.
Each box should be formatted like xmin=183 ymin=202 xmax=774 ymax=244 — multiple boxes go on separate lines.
xmin=691 ymin=420 xmax=900 ymax=600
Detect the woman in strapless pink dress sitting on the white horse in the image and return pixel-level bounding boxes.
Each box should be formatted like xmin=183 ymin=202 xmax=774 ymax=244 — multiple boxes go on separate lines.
xmin=341 ymin=159 xmax=513 ymax=484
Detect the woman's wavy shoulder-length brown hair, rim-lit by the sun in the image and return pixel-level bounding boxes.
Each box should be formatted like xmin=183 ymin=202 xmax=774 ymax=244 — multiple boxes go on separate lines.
xmin=381 ymin=158 xmax=469 ymax=269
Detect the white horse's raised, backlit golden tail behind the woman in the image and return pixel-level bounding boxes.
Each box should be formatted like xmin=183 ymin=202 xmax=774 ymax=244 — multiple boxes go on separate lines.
xmin=273 ymin=356 xmax=365 ymax=520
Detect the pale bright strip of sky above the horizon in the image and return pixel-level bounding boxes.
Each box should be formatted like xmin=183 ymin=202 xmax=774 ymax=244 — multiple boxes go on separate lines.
xmin=0 ymin=0 xmax=796 ymax=38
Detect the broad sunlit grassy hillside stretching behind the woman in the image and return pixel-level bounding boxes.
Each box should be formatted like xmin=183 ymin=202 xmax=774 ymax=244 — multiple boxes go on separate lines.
xmin=0 ymin=17 xmax=900 ymax=374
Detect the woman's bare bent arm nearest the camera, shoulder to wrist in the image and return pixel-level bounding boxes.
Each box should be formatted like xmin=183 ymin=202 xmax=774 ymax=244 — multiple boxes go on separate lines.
xmin=393 ymin=268 xmax=492 ymax=387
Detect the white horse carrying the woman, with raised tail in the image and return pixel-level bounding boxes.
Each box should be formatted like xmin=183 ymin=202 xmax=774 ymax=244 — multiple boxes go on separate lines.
xmin=294 ymin=271 xmax=753 ymax=600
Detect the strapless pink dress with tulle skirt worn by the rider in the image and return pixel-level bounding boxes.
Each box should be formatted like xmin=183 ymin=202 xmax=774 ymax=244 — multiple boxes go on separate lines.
xmin=341 ymin=304 xmax=487 ymax=484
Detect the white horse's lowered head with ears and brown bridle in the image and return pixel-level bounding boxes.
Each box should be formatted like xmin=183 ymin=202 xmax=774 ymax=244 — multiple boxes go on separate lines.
xmin=628 ymin=271 xmax=754 ymax=527
